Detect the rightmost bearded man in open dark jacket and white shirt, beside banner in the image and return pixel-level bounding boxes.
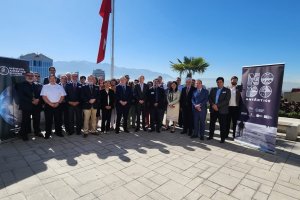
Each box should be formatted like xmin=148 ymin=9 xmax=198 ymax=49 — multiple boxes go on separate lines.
xmin=226 ymin=76 xmax=242 ymax=140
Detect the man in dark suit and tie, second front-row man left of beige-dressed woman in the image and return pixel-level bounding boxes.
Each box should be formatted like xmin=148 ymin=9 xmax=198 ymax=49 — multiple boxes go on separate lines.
xmin=133 ymin=75 xmax=149 ymax=132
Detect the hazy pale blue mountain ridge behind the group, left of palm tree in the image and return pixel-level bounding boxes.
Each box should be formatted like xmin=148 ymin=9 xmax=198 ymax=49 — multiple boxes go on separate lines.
xmin=54 ymin=61 xmax=175 ymax=81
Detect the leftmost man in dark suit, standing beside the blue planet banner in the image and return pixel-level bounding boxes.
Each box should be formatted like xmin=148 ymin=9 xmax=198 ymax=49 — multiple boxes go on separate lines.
xmin=18 ymin=72 xmax=39 ymax=141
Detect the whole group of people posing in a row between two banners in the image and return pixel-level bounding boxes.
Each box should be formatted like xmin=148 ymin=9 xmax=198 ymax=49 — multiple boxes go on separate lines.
xmin=17 ymin=66 xmax=241 ymax=143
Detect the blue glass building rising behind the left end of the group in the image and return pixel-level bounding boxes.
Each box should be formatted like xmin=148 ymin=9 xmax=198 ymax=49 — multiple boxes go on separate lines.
xmin=20 ymin=53 xmax=53 ymax=80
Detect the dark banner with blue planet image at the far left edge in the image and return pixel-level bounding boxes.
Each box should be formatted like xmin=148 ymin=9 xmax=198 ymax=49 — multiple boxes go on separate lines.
xmin=0 ymin=57 xmax=29 ymax=141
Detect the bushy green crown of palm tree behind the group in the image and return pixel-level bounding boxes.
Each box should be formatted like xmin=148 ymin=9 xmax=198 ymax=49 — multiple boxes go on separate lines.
xmin=170 ymin=56 xmax=209 ymax=78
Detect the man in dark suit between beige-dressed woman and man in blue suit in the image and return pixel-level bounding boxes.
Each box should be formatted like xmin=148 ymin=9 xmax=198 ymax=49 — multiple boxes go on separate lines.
xmin=180 ymin=78 xmax=195 ymax=136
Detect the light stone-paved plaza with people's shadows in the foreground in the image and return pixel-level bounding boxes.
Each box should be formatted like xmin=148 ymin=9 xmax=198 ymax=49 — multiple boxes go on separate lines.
xmin=0 ymin=130 xmax=300 ymax=200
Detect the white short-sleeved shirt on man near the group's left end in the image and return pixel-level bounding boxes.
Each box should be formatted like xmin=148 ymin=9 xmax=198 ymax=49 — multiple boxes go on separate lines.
xmin=41 ymin=83 xmax=67 ymax=103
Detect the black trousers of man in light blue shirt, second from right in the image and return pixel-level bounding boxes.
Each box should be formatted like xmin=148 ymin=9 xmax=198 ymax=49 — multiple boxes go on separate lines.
xmin=209 ymin=112 xmax=227 ymax=141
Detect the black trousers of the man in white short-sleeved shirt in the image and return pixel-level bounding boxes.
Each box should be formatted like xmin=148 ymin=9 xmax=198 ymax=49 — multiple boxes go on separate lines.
xmin=45 ymin=105 xmax=62 ymax=136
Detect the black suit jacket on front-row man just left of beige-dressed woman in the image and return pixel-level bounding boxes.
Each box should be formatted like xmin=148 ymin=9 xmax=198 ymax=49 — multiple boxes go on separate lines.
xmin=147 ymin=87 xmax=166 ymax=109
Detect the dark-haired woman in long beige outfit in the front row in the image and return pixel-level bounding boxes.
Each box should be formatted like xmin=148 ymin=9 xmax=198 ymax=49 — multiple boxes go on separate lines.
xmin=166 ymin=81 xmax=180 ymax=133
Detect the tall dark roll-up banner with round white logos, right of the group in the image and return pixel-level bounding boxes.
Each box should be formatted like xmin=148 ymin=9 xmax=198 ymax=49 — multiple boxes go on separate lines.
xmin=236 ymin=64 xmax=284 ymax=153
